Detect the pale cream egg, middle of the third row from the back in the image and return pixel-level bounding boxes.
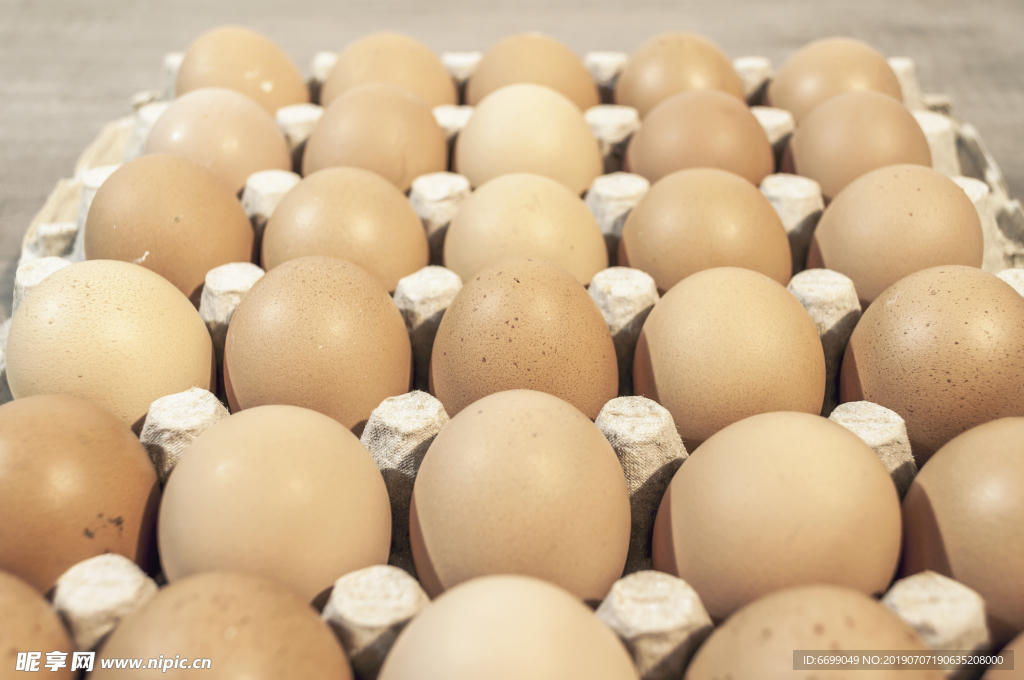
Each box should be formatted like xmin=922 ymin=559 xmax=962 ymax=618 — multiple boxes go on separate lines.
xmin=444 ymin=173 xmax=608 ymax=286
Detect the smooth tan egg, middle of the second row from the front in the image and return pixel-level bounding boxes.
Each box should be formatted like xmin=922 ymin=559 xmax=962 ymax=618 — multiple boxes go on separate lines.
xmin=410 ymin=389 xmax=630 ymax=602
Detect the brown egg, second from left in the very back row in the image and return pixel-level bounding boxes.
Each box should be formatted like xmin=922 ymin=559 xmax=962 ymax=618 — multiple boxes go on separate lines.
xmin=321 ymin=33 xmax=459 ymax=107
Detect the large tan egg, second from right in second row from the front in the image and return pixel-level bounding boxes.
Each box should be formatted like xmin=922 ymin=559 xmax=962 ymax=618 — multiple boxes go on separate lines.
xmin=652 ymin=412 xmax=900 ymax=621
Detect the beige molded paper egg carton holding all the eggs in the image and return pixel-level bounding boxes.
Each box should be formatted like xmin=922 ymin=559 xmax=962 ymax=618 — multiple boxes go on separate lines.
xmin=0 ymin=52 xmax=1024 ymax=680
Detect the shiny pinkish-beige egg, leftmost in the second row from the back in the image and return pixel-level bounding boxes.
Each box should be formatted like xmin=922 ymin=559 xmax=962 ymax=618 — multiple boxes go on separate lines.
xmin=145 ymin=87 xmax=292 ymax=193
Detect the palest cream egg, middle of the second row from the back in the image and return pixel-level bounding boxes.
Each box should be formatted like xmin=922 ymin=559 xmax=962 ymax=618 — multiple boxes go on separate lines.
xmin=455 ymin=83 xmax=603 ymax=196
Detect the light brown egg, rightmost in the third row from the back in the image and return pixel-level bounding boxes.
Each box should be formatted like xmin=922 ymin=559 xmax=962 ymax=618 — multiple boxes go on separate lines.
xmin=807 ymin=165 xmax=984 ymax=308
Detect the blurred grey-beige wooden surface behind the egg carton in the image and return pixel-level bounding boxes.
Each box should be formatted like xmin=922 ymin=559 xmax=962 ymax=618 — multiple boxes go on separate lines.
xmin=0 ymin=0 xmax=1024 ymax=320
